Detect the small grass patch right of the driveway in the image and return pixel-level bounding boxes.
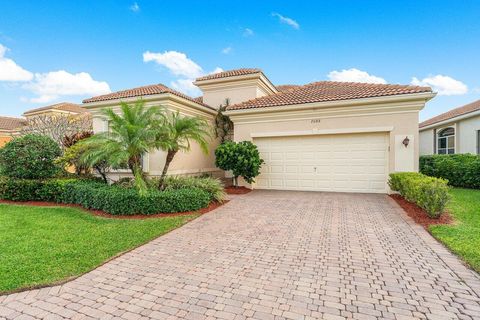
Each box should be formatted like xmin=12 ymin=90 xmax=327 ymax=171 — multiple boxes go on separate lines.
xmin=429 ymin=188 xmax=480 ymax=272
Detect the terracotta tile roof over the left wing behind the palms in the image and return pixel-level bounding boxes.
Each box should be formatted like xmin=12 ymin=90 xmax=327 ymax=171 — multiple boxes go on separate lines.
xmin=83 ymin=83 xmax=208 ymax=107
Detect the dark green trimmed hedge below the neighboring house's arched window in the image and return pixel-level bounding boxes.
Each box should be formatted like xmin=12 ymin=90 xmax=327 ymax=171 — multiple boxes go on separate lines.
xmin=420 ymin=153 xmax=480 ymax=189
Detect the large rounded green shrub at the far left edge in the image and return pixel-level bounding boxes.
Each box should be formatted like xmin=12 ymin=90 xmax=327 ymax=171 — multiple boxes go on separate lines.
xmin=0 ymin=134 xmax=62 ymax=179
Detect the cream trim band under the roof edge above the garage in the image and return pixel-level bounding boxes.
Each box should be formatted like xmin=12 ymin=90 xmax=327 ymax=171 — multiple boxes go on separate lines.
xmin=225 ymin=92 xmax=435 ymax=116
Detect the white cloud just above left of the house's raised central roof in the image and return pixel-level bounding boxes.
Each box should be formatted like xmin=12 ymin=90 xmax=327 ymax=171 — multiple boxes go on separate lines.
xmin=143 ymin=51 xmax=203 ymax=79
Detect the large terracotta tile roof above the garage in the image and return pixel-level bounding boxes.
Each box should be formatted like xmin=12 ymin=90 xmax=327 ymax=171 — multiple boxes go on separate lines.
xmin=228 ymin=81 xmax=432 ymax=110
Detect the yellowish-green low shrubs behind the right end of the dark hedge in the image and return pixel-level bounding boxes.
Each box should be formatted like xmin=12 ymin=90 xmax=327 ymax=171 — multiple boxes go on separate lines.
xmin=158 ymin=176 xmax=226 ymax=202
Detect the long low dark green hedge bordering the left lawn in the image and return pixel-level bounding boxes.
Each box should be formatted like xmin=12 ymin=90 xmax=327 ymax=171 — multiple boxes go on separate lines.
xmin=0 ymin=178 xmax=210 ymax=215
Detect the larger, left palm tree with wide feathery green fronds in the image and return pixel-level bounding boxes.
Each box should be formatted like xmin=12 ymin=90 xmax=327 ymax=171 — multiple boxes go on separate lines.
xmin=81 ymin=100 xmax=166 ymax=194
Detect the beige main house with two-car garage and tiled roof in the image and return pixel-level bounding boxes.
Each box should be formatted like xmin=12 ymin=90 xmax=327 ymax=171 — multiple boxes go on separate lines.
xmin=83 ymin=69 xmax=435 ymax=193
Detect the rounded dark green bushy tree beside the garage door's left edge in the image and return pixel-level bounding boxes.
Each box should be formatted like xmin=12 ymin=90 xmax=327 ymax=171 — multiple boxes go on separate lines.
xmin=215 ymin=141 xmax=264 ymax=187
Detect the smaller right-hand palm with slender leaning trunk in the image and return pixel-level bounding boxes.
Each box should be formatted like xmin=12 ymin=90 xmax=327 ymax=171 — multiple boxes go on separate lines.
xmin=157 ymin=112 xmax=212 ymax=188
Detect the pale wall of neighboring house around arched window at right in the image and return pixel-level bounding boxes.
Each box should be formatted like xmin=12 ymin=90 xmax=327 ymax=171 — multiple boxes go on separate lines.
xmin=420 ymin=115 xmax=480 ymax=155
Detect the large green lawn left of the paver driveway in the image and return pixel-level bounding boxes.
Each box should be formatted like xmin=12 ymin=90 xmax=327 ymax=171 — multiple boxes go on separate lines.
xmin=0 ymin=204 xmax=196 ymax=292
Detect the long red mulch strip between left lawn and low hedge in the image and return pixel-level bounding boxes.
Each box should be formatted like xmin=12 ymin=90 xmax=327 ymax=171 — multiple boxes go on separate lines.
xmin=0 ymin=200 xmax=228 ymax=220
